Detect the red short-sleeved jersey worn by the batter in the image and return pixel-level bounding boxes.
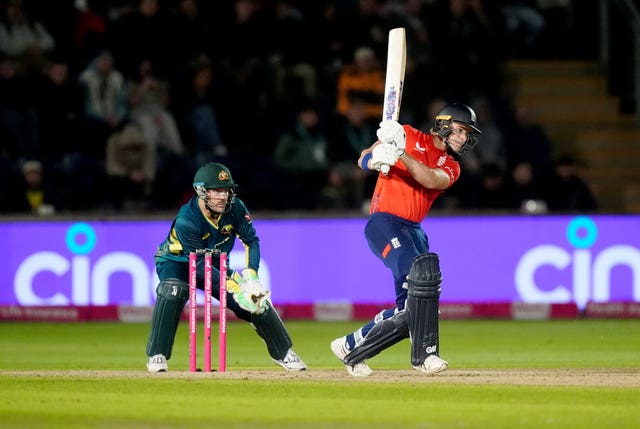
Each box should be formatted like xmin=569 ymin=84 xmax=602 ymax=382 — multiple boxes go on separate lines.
xmin=370 ymin=125 xmax=460 ymax=222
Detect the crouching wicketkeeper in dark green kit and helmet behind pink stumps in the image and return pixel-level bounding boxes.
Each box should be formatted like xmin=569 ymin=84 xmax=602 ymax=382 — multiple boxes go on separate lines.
xmin=147 ymin=162 xmax=307 ymax=372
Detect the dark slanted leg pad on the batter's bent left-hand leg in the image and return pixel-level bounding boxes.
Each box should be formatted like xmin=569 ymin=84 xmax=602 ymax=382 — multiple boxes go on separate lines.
xmin=344 ymin=311 xmax=409 ymax=365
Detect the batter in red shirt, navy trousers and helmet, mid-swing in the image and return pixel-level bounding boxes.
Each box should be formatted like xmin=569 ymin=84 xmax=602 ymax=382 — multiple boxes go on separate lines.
xmin=331 ymin=103 xmax=480 ymax=377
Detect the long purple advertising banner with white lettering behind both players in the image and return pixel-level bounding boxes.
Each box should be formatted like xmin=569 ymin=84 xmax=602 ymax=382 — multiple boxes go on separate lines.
xmin=0 ymin=215 xmax=640 ymax=309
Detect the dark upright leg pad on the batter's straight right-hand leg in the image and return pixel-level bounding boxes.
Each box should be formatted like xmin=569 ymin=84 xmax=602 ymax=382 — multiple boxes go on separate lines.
xmin=406 ymin=253 xmax=442 ymax=366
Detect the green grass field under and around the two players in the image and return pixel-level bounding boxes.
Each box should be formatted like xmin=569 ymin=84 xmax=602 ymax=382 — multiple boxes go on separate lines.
xmin=0 ymin=320 xmax=640 ymax=429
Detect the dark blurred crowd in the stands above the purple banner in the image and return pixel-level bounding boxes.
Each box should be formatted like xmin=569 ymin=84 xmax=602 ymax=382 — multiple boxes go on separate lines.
xmin=0 ymin=0 xmax=597 ymax=214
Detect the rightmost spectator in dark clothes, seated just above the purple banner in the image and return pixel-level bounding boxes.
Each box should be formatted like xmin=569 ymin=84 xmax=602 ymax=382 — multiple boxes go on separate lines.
xmin=547 ymin=155 xmax=598 ymax=212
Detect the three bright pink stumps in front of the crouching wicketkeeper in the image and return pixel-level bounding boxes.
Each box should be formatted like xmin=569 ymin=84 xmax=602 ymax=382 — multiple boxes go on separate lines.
xmin=189 ymin=249 xmax=227 ymax=372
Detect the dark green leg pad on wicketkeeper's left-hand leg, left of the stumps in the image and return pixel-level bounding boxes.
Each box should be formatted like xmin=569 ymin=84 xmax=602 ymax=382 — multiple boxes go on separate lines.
xmin=147 ymin=279 xmax=189 ymax=359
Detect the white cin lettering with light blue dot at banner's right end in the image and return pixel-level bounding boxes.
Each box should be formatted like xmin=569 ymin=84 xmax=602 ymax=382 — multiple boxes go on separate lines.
xmin=515 ymin=216 xmax=640 ymax=310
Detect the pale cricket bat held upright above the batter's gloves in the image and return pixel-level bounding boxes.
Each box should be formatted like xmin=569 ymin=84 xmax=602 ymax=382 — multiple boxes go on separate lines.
xmin=381 ymin=27 xmax=407 ymax=175
